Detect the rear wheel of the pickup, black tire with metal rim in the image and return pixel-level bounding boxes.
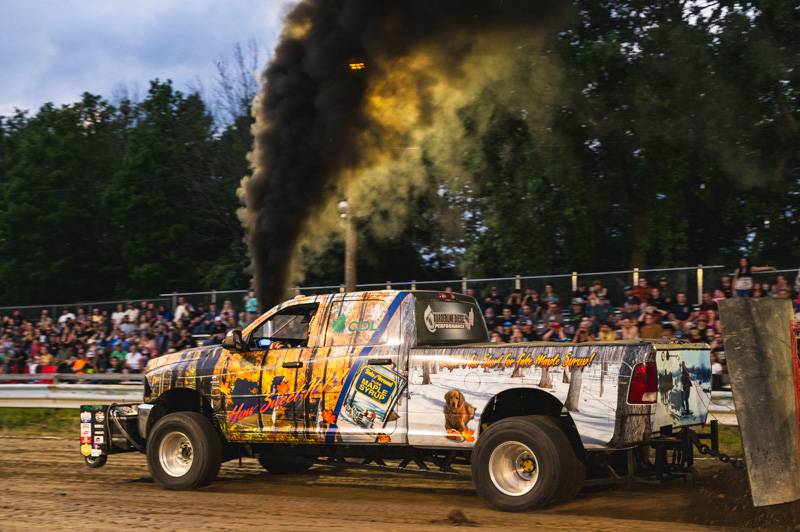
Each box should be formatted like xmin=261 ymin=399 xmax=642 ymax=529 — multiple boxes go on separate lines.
xmin=470 ymin=416 xmax=563 ymax=512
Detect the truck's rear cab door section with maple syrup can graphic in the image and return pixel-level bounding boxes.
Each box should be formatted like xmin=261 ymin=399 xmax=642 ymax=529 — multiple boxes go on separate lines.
xmin=310 ymin=292 xmax=410 ymax=444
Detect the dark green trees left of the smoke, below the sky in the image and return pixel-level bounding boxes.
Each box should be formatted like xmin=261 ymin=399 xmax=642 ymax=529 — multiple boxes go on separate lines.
xmin=0 ymin=81 xmax=251 ymax=303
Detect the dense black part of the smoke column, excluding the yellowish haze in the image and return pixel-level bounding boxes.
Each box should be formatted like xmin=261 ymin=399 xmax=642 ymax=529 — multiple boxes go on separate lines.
xmin=242 ymin=0 xmax=563 ymax=308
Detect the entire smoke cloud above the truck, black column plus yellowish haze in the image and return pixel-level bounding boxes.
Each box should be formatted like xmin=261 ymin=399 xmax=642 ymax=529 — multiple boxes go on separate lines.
xmin=239 ymin=0 xmax=563 ymax=308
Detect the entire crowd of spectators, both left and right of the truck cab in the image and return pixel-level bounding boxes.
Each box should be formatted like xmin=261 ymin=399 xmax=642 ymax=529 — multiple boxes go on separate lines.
xmin=0 ymin=266 xmax=800 ymax=382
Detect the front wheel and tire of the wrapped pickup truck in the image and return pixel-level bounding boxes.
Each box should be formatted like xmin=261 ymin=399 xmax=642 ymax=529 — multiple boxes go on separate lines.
xmin=147 ymin=412 xmax=222 ymax=490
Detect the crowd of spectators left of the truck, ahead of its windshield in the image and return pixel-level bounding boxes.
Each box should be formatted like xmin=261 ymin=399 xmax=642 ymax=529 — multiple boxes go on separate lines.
xmin=0 ymin=291 xmax=258 ymax=374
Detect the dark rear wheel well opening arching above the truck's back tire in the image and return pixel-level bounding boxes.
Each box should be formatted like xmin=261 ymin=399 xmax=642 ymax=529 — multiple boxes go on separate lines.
xmin=479 ymin=388 xmax=585 ymax=457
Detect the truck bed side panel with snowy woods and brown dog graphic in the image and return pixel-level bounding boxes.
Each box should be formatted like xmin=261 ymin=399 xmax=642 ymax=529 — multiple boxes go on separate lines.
xmin=408 ymin=343 xmax=652 ymax=447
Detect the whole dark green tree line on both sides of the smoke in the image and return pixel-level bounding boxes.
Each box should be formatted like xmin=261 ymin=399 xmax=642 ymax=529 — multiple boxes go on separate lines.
xmin=0 ymin=0 xmax=800 ymax=305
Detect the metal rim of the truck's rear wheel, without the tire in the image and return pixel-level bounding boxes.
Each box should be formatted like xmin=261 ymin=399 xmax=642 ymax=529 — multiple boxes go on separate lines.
xmin=489 ymin=441 xmax=539 ymax=497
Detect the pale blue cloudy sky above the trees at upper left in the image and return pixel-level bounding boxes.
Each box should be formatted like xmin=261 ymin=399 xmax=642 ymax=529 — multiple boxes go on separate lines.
xmin=0 ymin=0 xmax=290 ymax=115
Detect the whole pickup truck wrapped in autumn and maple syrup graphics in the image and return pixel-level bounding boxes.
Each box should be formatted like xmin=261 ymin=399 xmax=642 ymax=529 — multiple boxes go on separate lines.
xmin=80 ymin=290 xmax=711 ymax=511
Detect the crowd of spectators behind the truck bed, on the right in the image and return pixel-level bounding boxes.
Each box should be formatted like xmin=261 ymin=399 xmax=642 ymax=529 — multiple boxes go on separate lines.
xmin=468 ymin=268 xmax=800 ymax=388
